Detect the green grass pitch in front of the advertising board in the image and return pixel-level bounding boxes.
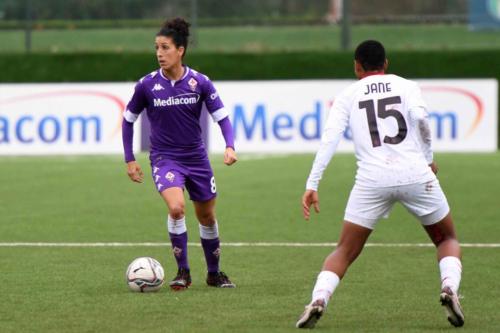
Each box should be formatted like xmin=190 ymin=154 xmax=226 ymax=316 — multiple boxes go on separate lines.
xmin=0 ymin=153 xmax=500 ymax=333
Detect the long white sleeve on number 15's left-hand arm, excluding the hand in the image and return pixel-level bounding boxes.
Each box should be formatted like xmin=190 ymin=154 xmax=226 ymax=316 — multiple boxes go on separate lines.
xmin=306 ymin=96 xmax=349 ymax=191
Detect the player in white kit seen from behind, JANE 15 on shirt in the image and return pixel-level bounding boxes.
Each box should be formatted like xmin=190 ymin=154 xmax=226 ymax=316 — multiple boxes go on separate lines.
xmin=296 ymin=40 xmax=464 ymax=328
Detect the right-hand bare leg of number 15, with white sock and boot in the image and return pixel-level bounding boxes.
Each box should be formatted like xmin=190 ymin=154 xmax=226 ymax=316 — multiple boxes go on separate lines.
xmin=424 ymin=213 xmax=464 ymax=327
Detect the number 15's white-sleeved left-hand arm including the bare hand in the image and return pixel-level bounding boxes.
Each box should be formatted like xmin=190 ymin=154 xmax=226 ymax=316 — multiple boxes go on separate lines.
xmin=302 ymin=94 xmax=349 ymax=220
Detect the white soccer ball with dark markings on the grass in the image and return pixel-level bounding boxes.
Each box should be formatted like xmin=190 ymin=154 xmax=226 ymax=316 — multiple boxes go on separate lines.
xmin=126 ymin=257 xmax=165 ymax=293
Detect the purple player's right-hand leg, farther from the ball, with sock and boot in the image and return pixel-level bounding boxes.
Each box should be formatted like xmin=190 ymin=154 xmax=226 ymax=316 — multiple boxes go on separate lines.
xmin=193 ymin=198 xmax=236 ymax=288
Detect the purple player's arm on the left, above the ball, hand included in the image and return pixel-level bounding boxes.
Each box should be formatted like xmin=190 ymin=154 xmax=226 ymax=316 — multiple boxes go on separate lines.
xmin=122 ymin=82 xmax=147 ymax=183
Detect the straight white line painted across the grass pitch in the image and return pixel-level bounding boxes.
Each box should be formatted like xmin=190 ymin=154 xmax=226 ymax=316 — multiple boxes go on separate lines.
xmin=0 ymin=242 xmax=500 ymax=248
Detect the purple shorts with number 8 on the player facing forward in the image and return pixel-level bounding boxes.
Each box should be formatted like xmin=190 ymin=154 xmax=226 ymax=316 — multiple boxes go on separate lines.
xmin=151 ymin=158 xmax=217 ymax=202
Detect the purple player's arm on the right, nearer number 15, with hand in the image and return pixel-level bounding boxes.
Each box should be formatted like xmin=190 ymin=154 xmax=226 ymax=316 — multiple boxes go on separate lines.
xmin=203 ymin=78 xmax=238 ymax=165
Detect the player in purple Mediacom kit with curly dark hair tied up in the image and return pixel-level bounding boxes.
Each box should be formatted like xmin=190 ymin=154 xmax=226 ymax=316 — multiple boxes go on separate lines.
xmin=122 ymin=18 xmax=237 ymax=290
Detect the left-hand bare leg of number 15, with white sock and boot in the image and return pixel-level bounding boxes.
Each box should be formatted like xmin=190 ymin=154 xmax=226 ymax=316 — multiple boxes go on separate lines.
xmin=295 ymin=221 xmax=372 ymax=328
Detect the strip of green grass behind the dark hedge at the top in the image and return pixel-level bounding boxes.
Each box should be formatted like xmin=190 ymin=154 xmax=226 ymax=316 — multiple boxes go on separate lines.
xmin=0 ymin=24 xmax=500 ymax=52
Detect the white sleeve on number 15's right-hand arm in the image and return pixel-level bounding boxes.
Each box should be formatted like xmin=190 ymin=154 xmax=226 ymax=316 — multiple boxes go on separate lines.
xmin=407 ymin=83 xmax=434 ymax=164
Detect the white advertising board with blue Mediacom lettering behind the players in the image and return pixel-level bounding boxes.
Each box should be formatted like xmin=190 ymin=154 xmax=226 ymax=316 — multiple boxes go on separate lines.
xmin=0 ymin=79 xmax=498 ymax=155
